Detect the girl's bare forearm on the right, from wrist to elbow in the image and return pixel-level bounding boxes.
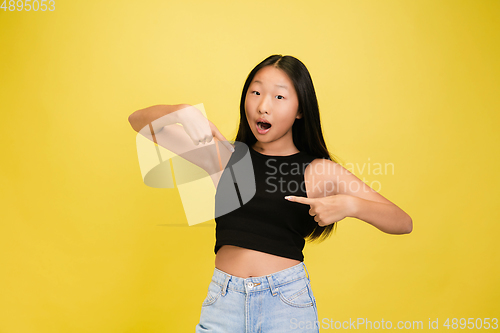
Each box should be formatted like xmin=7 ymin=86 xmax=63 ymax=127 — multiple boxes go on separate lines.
xmin=351 ymin=196 xmax=413 ymax=234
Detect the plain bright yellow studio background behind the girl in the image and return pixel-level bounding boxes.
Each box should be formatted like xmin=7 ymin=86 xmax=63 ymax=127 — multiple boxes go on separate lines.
xmin=0 ymin=0 xmax=500 ymax=333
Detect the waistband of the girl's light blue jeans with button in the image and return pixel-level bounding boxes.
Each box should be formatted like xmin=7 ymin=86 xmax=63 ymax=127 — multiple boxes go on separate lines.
xmin=212 ymin=262 xmax=309 ymax=296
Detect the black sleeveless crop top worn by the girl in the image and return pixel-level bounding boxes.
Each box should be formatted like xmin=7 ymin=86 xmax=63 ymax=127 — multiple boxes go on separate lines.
xmin=214 ymin=142 xmax=318 ymax=261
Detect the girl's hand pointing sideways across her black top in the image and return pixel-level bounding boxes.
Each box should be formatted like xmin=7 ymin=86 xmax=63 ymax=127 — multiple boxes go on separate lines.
xmin=285 ymin=194 xmax=355 ymax=227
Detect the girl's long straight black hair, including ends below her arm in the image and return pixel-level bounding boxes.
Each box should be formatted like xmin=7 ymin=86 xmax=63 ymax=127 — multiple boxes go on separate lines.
xmin=235 ymin=54 xmax=337 ymax=241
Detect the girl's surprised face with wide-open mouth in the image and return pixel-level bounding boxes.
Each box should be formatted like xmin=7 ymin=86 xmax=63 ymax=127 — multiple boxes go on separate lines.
xmin=245 ymin=66 xmax=302 ymax=146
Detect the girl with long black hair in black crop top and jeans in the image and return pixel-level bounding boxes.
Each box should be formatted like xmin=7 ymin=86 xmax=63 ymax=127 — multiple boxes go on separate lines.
xmin=129 ymin=55 xmax=412 ymax=333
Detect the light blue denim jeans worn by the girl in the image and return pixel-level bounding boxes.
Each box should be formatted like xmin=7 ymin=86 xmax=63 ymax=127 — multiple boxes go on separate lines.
xmin=196 ymin=262 xmax=319 ymax=333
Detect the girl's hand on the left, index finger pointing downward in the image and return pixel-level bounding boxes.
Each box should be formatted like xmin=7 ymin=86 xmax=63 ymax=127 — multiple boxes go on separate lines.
xmin=176 ymin=104 xmax=234 ymax=152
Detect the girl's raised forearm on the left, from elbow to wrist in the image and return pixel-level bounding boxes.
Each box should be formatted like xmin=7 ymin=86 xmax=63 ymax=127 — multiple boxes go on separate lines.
xmin=128 ymin=104 xmax=189 ymax=134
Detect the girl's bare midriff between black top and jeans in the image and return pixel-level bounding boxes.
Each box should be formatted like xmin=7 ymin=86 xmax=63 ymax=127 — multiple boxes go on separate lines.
xmin=215 ymin=245 xmax=300 ymax=278
